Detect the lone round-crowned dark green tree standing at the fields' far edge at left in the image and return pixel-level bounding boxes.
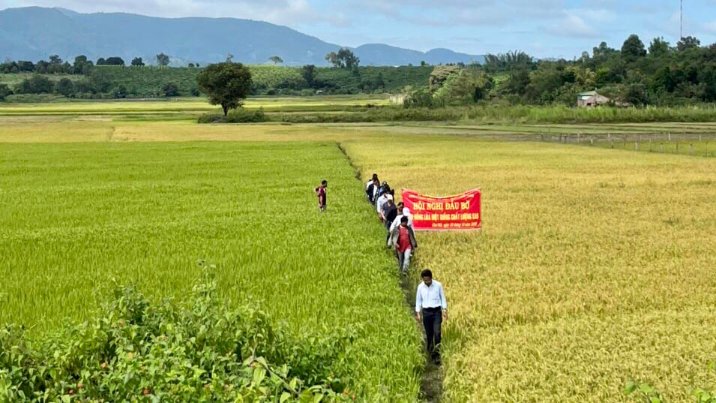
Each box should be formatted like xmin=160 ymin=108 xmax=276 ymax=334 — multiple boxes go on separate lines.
xmin=196 ymin=62 xmax=251 ymax=116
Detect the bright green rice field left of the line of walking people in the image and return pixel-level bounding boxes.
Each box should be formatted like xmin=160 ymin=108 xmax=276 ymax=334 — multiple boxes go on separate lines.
xmin=0 ymin=142 xmax=422 ymax=401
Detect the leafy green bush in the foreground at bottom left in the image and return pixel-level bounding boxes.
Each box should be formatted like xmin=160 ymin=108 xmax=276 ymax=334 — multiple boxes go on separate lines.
xmin=0 ymin=267 xmax=355 ymax=402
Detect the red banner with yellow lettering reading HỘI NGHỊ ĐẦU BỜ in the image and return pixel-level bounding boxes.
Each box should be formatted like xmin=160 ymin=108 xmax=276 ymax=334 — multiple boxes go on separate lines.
xmin=403 ymin=189 xmax=482 ymax=231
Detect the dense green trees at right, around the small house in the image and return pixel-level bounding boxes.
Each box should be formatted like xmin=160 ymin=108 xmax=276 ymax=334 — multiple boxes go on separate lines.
xmin=405 ymin=35 xmax=716 ymax=107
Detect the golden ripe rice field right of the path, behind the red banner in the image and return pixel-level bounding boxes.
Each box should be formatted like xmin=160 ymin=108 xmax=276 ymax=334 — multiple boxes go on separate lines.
xmin=343 ymin=135 xmax=716 ymax=402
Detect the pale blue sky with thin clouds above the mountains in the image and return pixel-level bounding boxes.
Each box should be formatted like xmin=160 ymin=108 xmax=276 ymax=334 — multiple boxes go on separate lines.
xmin=0 ymin=0 xmax=716 ymax=59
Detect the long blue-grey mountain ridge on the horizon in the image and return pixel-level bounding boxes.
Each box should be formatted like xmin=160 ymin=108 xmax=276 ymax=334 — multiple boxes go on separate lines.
xmin=0 ymin=7 xmax=484 ymax=66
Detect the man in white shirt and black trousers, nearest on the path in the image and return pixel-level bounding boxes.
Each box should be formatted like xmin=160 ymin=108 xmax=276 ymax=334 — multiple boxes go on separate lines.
xmin=415 ymin=269 xmax=447 ymax=364
